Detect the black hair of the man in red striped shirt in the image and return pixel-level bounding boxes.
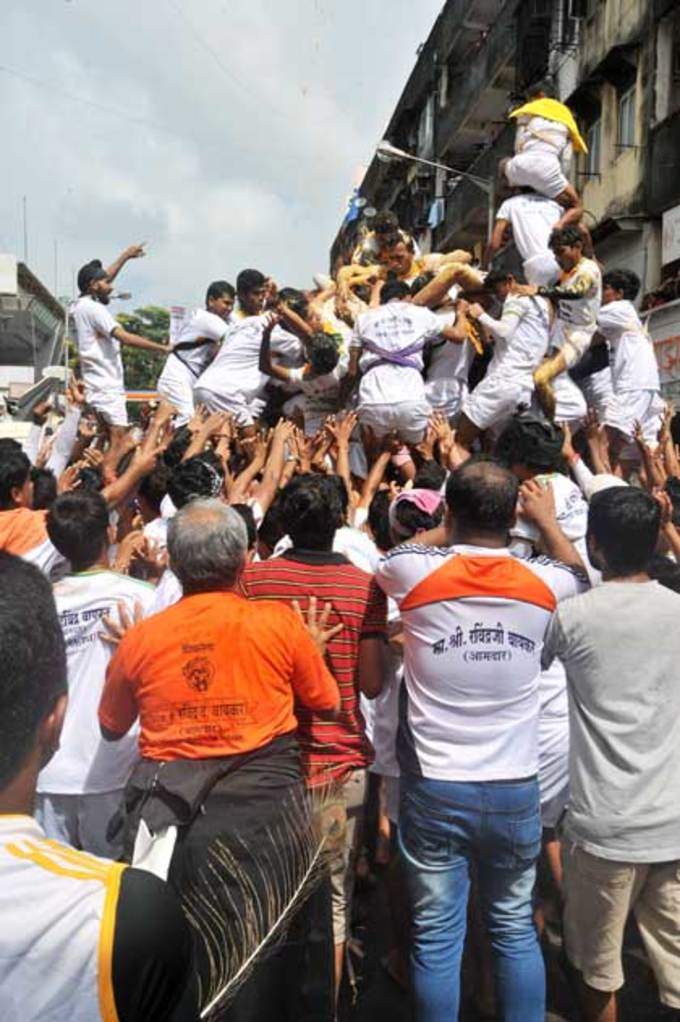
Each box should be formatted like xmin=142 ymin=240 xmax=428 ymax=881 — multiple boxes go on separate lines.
xmin=281 ymin=472 xmax=344 ymax=550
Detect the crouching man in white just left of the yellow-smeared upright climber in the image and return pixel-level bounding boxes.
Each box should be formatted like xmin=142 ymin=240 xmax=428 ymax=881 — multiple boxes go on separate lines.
xmin=456 ymin=270 xmax=553 ymax=450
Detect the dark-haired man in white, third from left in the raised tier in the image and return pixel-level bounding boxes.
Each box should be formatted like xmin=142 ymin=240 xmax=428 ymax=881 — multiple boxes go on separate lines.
xmin=194 ymin=270 xmax=268 ymax=432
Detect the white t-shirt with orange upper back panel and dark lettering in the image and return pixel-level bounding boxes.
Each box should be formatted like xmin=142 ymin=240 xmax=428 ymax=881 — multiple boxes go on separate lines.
xmin=375 ymin=545 xmax=586 ymax=781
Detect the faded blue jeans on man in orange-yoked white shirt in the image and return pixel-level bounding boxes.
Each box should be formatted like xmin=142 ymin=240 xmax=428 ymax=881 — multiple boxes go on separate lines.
xmin=399 ymin=775 xmax=545 ymax=1022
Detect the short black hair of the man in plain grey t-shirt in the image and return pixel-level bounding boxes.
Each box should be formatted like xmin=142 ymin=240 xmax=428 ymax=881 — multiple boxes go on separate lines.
xmin=587 ymin=486 xmax=661 ymax=577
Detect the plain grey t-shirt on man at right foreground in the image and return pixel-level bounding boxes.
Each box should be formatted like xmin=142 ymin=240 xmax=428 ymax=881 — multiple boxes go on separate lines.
xmin=543 ymin=582 xmax=680 ymax=863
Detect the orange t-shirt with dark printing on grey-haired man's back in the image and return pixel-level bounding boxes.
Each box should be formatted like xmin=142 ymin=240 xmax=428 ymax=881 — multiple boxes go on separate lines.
xmin=99 ymin=592 xmax=339 ymax=759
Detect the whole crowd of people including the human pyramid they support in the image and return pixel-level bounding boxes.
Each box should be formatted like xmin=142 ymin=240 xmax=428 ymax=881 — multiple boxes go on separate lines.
xmin=0 ymin=79 xmax=680 ymax=1022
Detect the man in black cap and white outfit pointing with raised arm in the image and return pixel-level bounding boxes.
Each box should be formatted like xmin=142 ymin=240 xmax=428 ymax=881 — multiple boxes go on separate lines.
xmin=71 ymin=253 xmax=168 ymax=439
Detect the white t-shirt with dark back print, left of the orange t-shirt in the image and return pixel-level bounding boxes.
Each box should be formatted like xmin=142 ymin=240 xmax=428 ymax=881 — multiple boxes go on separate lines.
xmin=38 ymin=570 xmax=153 ymax=795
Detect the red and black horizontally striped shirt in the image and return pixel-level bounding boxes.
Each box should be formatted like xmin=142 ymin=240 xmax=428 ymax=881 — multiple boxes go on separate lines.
xmin=240 ymin=549 xmax=388 ymax=786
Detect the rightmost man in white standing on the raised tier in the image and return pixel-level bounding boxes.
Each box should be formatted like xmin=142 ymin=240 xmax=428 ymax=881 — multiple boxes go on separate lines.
xmin=597 ymin=270 xmax=665 ymax=460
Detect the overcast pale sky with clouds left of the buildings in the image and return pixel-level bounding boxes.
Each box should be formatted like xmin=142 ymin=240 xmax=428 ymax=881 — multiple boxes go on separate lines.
xmin=0 ymin=0 xmax=442 ymax=308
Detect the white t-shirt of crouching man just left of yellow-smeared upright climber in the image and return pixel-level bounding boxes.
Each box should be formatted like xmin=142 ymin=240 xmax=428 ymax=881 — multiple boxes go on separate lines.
xmin=480 ymin=294 xmax=551 ymax=376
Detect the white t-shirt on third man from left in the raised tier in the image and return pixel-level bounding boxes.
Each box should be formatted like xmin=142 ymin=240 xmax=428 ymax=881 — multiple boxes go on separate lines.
xmin=196 ymin=316 xmax=269 ymax=402
